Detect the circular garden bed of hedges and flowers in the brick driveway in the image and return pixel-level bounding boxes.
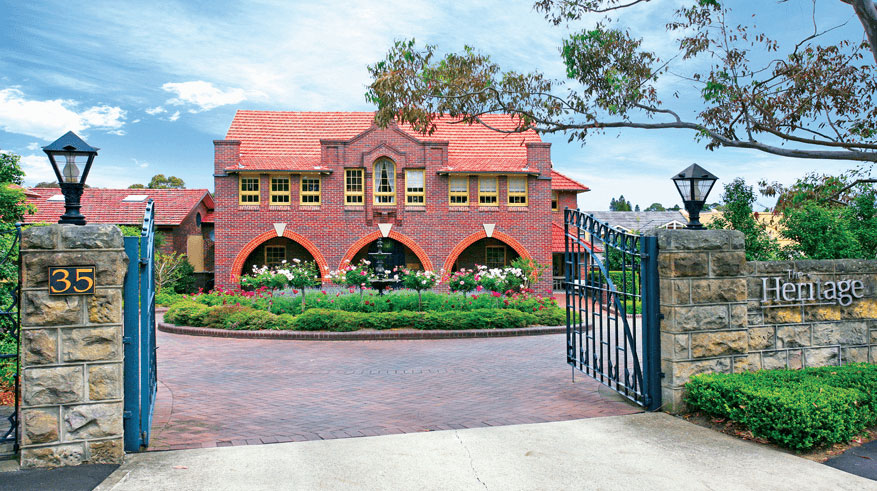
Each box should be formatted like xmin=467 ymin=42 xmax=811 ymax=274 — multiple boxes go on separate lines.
xmin=160 ymin=289 xmax=566 ymax=339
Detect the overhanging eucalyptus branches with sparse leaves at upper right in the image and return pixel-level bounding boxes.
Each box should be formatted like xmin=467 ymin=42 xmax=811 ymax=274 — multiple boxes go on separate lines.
xmin=366 ymin=0 xmax=877 ymax=165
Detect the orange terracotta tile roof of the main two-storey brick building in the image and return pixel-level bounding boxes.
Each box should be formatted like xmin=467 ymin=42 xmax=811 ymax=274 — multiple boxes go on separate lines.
xmin=226 ymin=111 xmax=542 ymax=172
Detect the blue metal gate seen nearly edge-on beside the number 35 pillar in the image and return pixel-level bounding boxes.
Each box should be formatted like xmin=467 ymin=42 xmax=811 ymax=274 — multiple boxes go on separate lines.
xmin=122 ymin=200 xmax=158 ymax=452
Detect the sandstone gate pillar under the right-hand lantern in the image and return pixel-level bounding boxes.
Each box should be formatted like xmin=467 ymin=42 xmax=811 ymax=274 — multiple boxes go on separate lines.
xmin=658 ymin=230 xmax=749 ymax=412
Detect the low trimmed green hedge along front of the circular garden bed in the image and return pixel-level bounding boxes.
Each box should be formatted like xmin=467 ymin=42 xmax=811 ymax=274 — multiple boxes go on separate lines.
xmin=164 ymin=301 xmax=548 ymax=331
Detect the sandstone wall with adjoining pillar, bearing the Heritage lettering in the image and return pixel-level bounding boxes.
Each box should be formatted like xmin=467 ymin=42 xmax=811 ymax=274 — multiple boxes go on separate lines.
xmin=658 ymin=230 xmax=877 ymax=412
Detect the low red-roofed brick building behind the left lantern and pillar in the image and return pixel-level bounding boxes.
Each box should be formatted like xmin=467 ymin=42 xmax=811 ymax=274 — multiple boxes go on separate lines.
xmin=25 ymin=188 xmax=214 ymax=274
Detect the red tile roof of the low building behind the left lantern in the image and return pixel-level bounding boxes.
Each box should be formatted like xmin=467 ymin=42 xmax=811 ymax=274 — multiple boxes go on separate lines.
xmin=25 ymin=188 xmax=213 ymax=226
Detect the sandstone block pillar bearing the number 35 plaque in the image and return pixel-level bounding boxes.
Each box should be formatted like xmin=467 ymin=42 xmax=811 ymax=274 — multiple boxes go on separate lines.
xmin=20 ymin=225 xmax=128 ymax=468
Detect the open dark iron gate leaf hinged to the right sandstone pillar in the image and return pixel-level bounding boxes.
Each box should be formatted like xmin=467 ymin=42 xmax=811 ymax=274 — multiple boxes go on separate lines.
xmin=563 ymin=209 xmax=661 ymax=410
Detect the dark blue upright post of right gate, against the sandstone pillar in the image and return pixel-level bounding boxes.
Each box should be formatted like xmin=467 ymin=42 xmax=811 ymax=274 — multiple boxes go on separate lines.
xmin=640 ymin=237 xmax=662 ymax=411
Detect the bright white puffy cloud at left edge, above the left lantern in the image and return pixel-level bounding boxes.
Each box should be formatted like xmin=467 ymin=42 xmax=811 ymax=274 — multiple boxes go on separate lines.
xmin=0 ymin=88 xmax=126 ymax=141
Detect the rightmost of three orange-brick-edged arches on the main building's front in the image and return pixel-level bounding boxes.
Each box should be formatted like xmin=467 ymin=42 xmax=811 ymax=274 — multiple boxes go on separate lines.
xmin=444 ymin=231 xmax=531 ymax=272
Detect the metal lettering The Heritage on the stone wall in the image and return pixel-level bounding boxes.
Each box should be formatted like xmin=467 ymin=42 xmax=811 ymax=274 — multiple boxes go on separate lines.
xmin=761 ymin=269 xmax=865 ymax=308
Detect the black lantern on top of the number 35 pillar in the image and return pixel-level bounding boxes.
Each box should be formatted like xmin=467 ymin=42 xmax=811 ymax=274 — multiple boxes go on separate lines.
xmin=43 ymin=131 xmax=100 ymax=225
